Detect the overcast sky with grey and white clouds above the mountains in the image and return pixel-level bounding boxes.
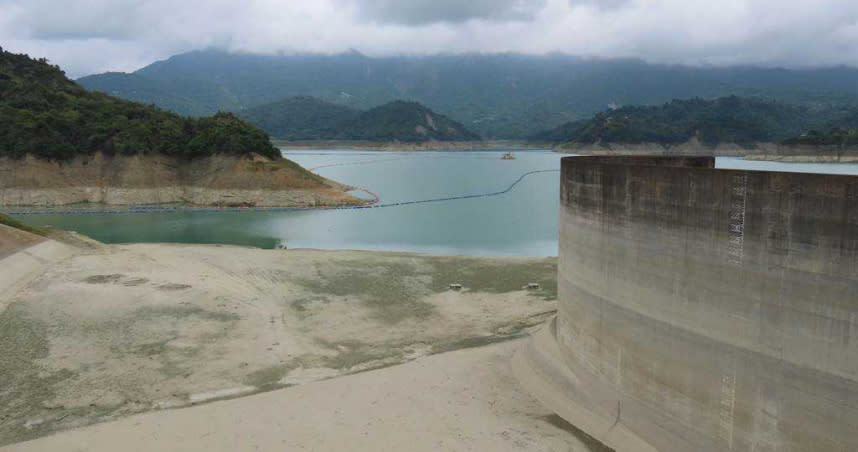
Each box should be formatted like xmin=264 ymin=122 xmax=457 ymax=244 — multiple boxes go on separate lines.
xmin=0 ymin=0 xmax=858 ymax=77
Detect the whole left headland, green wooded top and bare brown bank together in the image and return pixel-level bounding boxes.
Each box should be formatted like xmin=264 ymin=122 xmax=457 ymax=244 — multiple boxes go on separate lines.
xmin=0 ymin=49 xmax=363 ymax=207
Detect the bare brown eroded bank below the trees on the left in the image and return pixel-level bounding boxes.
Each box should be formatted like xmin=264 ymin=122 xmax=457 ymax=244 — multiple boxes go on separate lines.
xmin=0 ymin=153 xmax=362 ymax=207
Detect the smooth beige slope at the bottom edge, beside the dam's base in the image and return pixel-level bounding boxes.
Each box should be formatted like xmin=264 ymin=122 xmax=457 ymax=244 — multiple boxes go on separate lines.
xmin=2 ymin=341 xmax=604 ymax=452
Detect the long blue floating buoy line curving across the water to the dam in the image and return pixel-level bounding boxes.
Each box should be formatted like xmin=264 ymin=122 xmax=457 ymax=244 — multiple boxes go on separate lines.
xmin=7 ymin=168 xmax=560 ymax=215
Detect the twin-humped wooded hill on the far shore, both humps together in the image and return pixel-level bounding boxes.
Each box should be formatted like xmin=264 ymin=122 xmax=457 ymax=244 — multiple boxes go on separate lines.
xmin=240 ymin=97 xmax=480 ymax=143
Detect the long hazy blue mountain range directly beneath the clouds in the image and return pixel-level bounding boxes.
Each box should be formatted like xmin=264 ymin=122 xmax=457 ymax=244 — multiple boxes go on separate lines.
xmin=79 ymin=50 xmax=858 ymax=138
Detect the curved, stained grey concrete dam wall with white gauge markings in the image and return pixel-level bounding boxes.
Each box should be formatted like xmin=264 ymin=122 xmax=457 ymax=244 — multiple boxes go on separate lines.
xmin=513 ymin=157 xmax=858 ymax=452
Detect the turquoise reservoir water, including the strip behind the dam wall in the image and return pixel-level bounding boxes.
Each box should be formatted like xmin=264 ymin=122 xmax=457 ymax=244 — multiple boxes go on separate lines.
xmin=20 ymin=150 xmax=858 ymax=256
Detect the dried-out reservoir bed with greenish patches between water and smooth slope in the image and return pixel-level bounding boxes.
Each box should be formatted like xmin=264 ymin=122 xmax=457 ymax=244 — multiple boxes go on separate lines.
xmin=0 ymin=245 xmax=556 ymax=445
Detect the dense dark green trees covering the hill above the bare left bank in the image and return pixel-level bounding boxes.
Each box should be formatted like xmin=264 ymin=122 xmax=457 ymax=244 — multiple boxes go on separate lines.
xmin=0 ymin=49 xmax=280 ymax=159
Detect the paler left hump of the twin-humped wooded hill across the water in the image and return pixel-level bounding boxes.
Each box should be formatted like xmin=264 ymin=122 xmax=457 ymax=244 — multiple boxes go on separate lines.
xmin=238 ymin=96 xmax=361 ymax=140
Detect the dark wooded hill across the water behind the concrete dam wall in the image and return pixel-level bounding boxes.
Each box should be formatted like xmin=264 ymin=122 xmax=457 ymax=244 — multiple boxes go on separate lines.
xmin=531 ymin=96 xmax=858 ymax=146
